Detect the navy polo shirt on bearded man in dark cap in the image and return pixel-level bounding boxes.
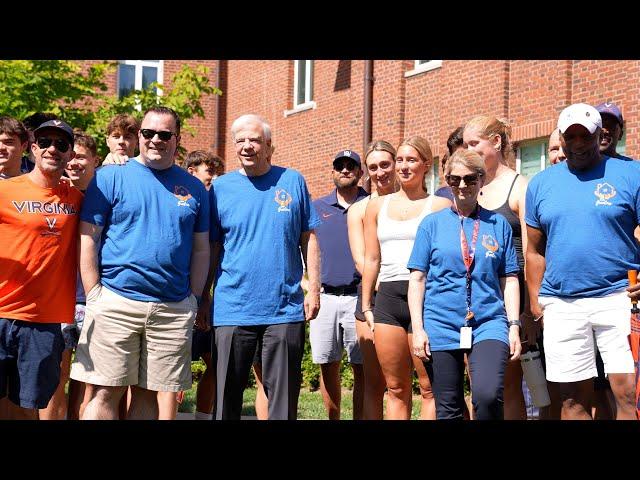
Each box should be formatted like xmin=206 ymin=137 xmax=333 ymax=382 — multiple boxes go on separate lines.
xmin=313 ymin=187 xmax=369 ymax=287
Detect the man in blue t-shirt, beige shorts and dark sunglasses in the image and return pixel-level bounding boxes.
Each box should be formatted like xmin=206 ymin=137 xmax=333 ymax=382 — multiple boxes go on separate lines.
xmin=71 ymin=107 xmax=209 ymax=419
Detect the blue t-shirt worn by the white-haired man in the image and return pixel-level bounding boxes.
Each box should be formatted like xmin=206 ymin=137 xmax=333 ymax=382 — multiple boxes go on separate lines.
xmin=209 ymin=166 xmax=320 ymax=327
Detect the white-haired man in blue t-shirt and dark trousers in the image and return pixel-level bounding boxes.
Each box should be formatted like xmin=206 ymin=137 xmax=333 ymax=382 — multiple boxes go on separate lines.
xmin=198 ymin=115 xmax=320 ymax=420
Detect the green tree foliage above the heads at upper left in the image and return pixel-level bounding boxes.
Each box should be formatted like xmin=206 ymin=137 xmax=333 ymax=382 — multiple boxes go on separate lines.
xmin=0 ymin=60 xmax=222 ymax=156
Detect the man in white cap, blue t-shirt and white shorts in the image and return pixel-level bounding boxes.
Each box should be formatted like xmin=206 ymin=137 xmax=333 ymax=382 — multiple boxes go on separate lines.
xmin=525 ymin=103 xmax=640 ymax=419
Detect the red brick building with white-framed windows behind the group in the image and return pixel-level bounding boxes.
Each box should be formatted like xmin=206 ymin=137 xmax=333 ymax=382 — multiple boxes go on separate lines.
xmin=94 ymin=60 xmax=640 ymax=197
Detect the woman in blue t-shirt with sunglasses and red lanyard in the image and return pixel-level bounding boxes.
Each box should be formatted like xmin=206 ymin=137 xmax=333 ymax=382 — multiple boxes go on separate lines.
xmin=407 ymin=150 xmax=521 ymax=420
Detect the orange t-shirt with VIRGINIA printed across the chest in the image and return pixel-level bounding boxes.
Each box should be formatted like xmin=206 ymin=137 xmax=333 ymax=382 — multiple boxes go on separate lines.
xmin=0 ymin=174 xmax=83 ymax=323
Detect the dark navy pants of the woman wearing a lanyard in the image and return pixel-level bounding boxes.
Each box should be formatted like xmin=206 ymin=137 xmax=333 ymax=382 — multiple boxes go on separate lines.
xmin=428 ymin=340 xmax=509 ymax=420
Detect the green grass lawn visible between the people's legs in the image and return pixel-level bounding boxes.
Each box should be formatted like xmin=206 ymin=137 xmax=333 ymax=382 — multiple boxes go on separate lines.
xmin=179 ymin=385 xmax=420 ymax=420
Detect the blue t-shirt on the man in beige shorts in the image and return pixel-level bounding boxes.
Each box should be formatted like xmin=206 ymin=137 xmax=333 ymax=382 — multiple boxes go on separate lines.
xmin=80 ymin=160 xmax=209 ymax=302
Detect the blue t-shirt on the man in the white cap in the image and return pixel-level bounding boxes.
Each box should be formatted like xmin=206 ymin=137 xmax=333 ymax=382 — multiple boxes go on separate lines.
xmin=525 ymin=157 xmax=640 ymax=298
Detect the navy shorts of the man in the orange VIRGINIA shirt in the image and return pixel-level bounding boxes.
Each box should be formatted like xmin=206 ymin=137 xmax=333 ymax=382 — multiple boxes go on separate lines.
xmin=0 ymin=318 xmax=64 ymax=408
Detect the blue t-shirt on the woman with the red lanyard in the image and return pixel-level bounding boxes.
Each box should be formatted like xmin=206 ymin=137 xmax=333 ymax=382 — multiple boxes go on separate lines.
xmin=407 ymin=208 xmax=520 ymax=351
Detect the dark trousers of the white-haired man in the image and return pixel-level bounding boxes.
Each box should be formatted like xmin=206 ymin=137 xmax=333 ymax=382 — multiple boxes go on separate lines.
xmin=215 ymin=322 xmax=305 ymax=420
